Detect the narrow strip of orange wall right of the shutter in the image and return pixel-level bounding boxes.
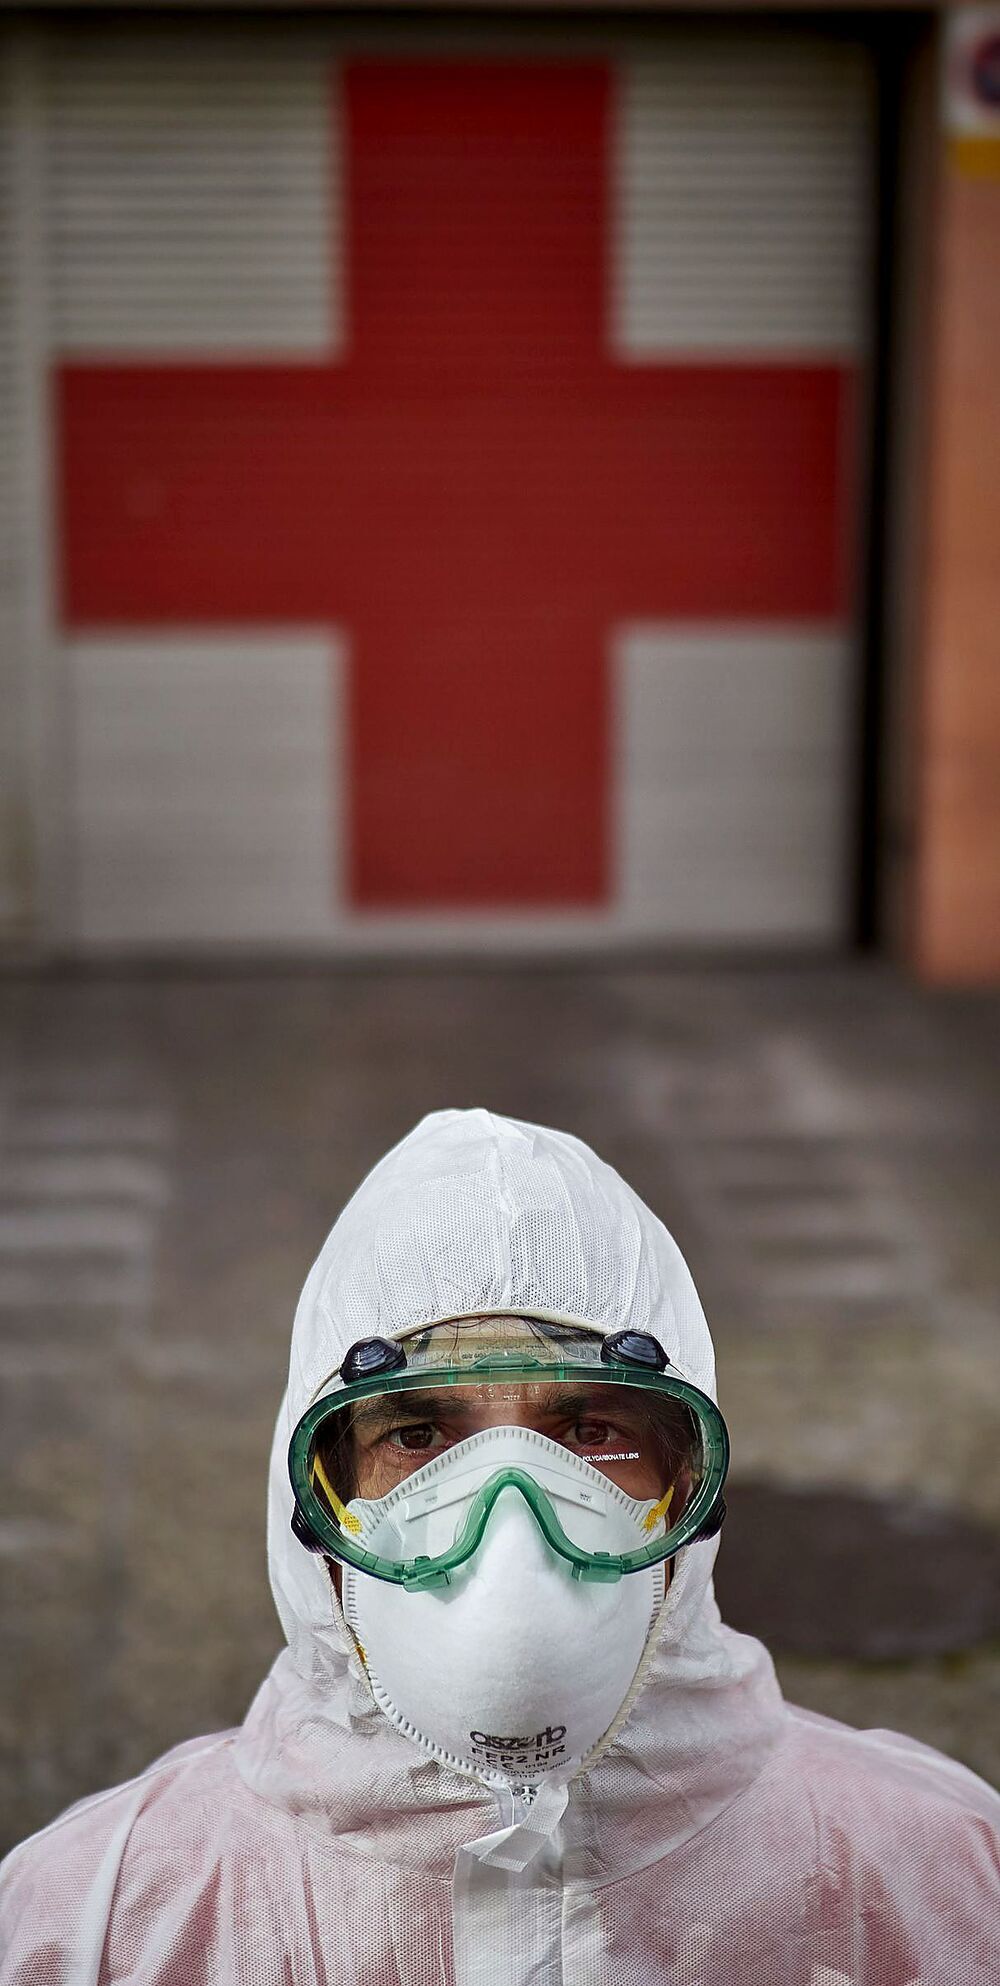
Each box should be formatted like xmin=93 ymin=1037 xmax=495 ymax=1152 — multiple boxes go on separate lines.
xmin=913 ymin=139 xmax=1000 ymax=981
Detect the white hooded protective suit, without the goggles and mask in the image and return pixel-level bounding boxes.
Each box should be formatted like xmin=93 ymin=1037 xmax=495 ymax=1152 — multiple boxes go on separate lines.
xmin=0 ymin=1110 xmax=1000 ymax=1986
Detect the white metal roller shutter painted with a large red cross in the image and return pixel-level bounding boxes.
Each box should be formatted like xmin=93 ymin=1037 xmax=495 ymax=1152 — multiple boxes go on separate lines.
xmin=17 ymin=20 xmax=869 ymax=949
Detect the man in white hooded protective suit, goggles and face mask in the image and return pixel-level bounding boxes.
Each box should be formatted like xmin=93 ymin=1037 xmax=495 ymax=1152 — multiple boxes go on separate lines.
xmin=0 ymin=1110 xmax=1000 ymax=1986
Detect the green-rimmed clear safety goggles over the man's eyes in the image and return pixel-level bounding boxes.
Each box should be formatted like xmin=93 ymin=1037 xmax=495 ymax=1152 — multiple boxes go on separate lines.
xmin=288 ymin=1317 xmax=730 ymax=1589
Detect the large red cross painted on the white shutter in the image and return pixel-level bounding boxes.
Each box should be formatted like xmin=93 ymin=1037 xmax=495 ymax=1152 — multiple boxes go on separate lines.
xmin=60 ymin=62 xmax=849 ymax=908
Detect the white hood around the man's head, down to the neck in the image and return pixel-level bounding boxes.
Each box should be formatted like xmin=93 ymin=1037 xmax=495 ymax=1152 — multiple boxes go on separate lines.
xmin=240 ymin=1110 xmax=784 ymax=1879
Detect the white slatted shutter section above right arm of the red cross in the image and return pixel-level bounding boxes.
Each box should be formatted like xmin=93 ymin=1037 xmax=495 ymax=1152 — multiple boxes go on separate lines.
xmin=613 ymin=30 xmax=871 ymax=359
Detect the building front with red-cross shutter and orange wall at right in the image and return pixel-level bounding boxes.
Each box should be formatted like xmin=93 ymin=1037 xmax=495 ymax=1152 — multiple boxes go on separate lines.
xmin=0 ymin=8 xmax=1000 ymax=979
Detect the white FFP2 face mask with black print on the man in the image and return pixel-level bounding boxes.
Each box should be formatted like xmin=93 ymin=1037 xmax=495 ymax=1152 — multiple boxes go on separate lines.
xmin=343 ymin=1428 xmax=665 ymax=1785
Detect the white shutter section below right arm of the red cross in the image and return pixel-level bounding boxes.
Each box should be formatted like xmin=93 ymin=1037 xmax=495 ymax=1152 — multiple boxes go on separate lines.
xmin=615 ymin=628 xmax=851 ymax=941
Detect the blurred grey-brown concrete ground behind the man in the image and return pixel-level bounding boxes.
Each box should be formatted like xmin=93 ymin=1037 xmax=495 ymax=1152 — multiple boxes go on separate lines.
xmin=0 ymin=965 xmax=1000 ymax=1843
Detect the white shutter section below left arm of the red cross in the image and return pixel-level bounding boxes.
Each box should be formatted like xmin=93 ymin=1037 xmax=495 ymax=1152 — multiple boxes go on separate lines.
xmin=65 ymin=632 xmax=343 ymax=945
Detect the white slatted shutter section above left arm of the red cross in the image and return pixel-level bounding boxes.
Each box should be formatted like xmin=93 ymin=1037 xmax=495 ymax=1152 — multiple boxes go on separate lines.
xmin=48 ymin=20 xmax=343 ymax=359
